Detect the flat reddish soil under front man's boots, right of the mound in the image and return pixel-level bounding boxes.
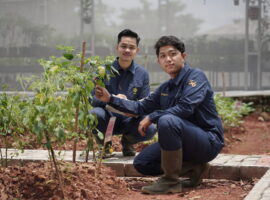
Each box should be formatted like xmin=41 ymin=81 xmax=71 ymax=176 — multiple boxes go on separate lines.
xmin=121 ymin=178 xmax=255 ymax=200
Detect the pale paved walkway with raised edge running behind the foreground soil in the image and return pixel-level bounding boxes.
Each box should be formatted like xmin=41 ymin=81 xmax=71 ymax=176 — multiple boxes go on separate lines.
xmin=1 ymin=149 xmax=270 ymax=200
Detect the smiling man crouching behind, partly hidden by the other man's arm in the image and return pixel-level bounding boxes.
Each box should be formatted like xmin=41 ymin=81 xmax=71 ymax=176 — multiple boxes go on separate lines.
xmin=91 ymin=29 xmax=156 ymax=156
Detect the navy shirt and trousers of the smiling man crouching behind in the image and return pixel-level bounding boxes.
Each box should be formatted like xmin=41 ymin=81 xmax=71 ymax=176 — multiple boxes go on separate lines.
xmin=91 ymin=59 xmax=156 ymax=144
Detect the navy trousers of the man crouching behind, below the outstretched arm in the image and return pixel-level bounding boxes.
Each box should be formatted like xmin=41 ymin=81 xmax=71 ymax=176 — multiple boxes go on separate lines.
xmin=90 ymin=107 xmax=156 ymax=144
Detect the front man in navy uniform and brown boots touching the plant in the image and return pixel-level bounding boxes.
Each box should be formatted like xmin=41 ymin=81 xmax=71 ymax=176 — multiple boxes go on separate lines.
xmin=95 ymin=36 xmax=224 ymax=194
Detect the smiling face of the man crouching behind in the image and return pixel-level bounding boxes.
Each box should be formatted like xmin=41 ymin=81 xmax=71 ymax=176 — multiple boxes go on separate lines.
xmin=116 ymin=37 xmax=139 ymax=62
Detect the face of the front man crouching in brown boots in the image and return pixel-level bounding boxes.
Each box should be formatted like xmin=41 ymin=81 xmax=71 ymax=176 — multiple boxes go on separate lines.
xmin=158 ymin=46 xmax=186 ymax=78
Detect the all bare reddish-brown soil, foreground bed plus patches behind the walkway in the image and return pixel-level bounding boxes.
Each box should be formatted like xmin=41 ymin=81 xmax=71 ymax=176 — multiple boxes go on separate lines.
xmin=0 ymin=111 xmax=270 ymax=200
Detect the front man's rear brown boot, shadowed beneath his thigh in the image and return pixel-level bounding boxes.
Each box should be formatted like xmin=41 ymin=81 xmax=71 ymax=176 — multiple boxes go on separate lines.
xmin=180 ymin=162 xmax=209 ymax=187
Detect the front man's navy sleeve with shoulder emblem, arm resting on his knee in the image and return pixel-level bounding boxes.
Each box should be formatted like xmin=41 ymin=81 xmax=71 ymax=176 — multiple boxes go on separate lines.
xmin=149 ymin=71 xmax=210 ymax=123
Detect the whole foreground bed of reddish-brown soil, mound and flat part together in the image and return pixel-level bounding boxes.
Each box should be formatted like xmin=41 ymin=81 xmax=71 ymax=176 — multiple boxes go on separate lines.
xmin=0 ymin=163 xmax=255 ymax=200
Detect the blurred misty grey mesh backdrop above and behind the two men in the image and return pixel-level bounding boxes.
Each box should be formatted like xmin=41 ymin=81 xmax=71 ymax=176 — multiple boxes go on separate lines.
xmin=0 ymin=0 xmax=270 ymax=91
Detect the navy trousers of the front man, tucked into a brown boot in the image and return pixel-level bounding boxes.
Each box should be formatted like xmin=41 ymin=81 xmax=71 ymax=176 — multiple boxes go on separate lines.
xmin=134 ymin=114 xmax=222 ymax=175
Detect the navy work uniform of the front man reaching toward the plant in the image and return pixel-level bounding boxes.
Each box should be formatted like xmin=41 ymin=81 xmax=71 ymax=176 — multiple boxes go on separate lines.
xmin=109 ymin=64 xmax=224 ymax=175
